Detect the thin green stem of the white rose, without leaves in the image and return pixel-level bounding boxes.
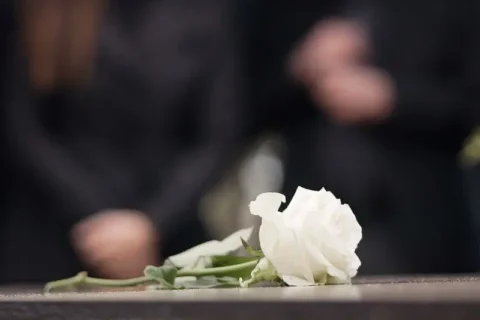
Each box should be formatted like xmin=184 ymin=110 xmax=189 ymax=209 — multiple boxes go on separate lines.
xmin=45 ymin=260 xmax=258 ymax=292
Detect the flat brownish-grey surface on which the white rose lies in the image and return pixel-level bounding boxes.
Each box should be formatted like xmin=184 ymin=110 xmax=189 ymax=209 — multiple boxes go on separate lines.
xmin=0 ymin=276 xmax=480 ymax=320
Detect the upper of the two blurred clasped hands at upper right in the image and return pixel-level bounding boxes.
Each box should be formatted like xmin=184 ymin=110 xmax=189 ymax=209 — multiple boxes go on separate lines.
xmin=290 ymin=20 xmax=369 ymax=86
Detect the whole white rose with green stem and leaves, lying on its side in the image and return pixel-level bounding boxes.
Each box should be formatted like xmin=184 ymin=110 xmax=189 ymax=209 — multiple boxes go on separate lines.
xmin=45 ymin=187 xmax=362 ymax=292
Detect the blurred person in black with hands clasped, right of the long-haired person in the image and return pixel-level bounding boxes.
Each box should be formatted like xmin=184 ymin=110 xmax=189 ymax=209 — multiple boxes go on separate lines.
xmin=242 ymin=0 xmax=480 ymax=274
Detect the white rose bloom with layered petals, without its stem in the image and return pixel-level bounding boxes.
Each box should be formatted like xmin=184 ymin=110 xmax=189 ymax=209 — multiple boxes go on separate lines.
xmin=250 ymin=187 xmax=362 ymax=286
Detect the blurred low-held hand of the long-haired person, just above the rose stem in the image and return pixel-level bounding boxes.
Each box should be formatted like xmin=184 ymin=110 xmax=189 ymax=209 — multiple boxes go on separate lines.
xmin=72 ymin=210 xmax=159 ymax=278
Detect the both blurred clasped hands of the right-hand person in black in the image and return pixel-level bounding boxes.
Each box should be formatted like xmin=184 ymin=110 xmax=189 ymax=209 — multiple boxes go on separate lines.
xmin=290 ymin=20 xmax=395 ymax=124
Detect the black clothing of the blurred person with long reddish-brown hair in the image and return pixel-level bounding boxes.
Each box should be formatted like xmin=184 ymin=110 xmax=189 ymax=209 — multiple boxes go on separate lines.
xmin=0 ymin=0 xmax=244 ymax=282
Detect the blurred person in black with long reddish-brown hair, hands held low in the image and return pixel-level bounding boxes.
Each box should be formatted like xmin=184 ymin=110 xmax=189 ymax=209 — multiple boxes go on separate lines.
xmin=0 ymin=0 xmax=243 ymax=283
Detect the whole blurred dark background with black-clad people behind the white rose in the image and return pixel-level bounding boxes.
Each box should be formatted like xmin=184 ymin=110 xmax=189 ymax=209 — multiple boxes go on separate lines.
xmin=0 ymin=0 xmax=480 ymax=284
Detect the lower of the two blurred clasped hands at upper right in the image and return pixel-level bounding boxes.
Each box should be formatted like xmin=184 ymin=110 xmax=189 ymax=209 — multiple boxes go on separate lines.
xmin=311 ymin=67 xmax=395 ymax=124
